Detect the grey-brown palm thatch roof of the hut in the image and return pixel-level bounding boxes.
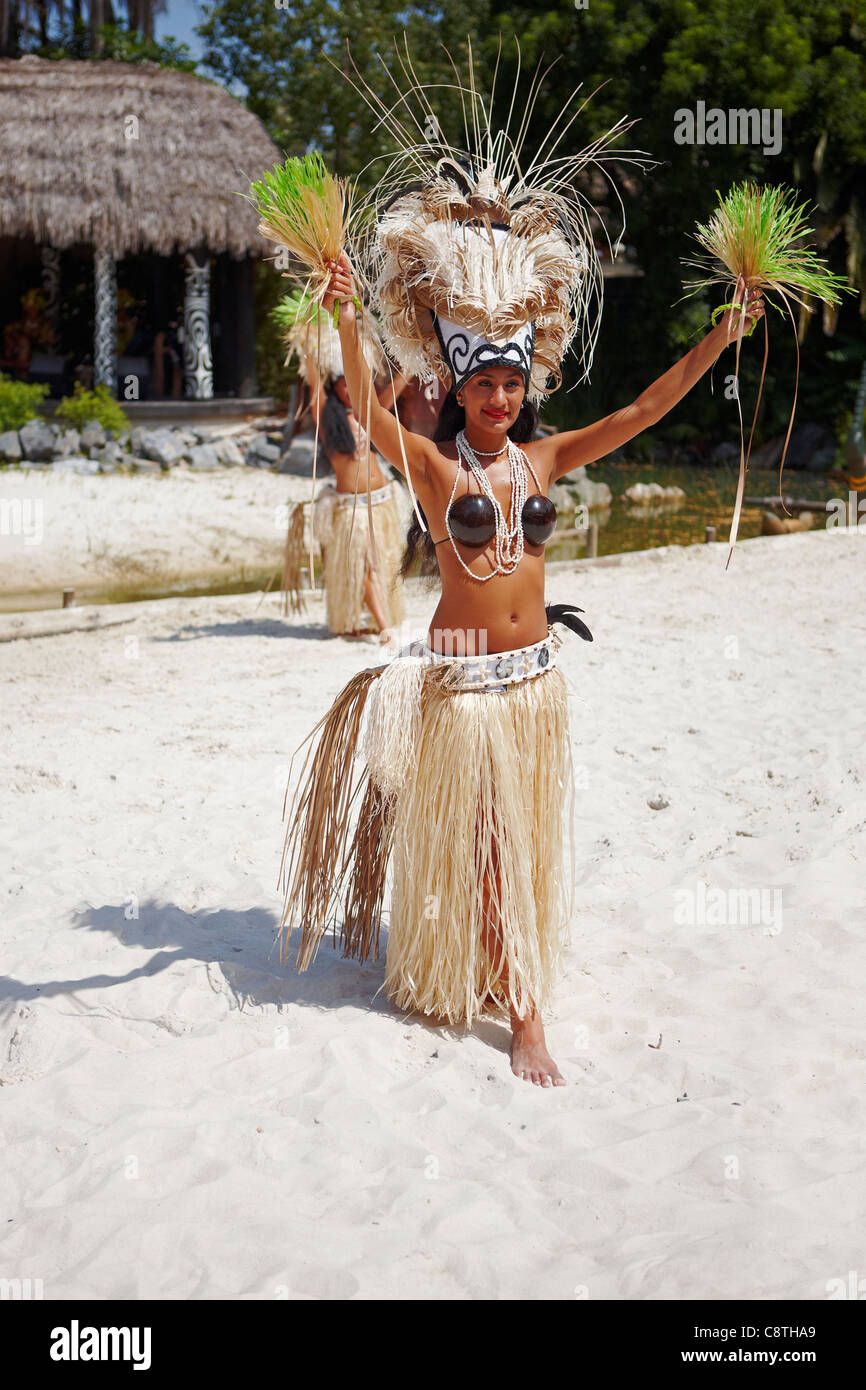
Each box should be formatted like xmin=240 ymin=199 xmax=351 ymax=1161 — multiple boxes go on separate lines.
xmin=0 ymin=56 xmax=282 ymax=257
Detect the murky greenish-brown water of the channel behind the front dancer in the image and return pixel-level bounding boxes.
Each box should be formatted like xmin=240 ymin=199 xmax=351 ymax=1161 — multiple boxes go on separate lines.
xmin=6 ymin=463 xmax=845 ymax=612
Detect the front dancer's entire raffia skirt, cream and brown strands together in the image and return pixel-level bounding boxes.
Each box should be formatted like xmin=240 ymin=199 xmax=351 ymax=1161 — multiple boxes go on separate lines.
xmin=279 ymin=632 xmax=574 ymax=1023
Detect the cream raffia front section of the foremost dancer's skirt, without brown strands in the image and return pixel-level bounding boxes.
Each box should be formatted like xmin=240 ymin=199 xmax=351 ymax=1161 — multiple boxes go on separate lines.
xmin=385 ymin=667 xmax=574 ymax=1023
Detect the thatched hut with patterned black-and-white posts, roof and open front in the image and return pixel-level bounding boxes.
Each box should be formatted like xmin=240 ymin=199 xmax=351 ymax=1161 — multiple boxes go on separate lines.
xmin=0 ymin=56 xmax=281 ymax=402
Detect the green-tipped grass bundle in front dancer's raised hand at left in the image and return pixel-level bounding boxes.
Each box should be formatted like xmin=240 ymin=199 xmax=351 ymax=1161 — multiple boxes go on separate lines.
xmin=250 ymin=153 xmax=352 ymax=312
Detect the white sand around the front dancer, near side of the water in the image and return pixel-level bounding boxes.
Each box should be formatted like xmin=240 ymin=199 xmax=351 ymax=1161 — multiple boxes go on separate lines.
xmin=0 ymin=522 xmax=866 ymax=1300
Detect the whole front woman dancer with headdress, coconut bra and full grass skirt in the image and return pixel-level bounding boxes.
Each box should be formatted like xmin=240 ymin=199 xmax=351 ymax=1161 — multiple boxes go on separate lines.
xmin=281 ymin=65 xmax=763 ymax=1087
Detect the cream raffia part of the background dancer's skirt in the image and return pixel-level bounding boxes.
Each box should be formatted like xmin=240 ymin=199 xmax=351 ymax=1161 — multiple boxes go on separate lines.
xmin=322 ymin=492 xmax=405 ymax=632
